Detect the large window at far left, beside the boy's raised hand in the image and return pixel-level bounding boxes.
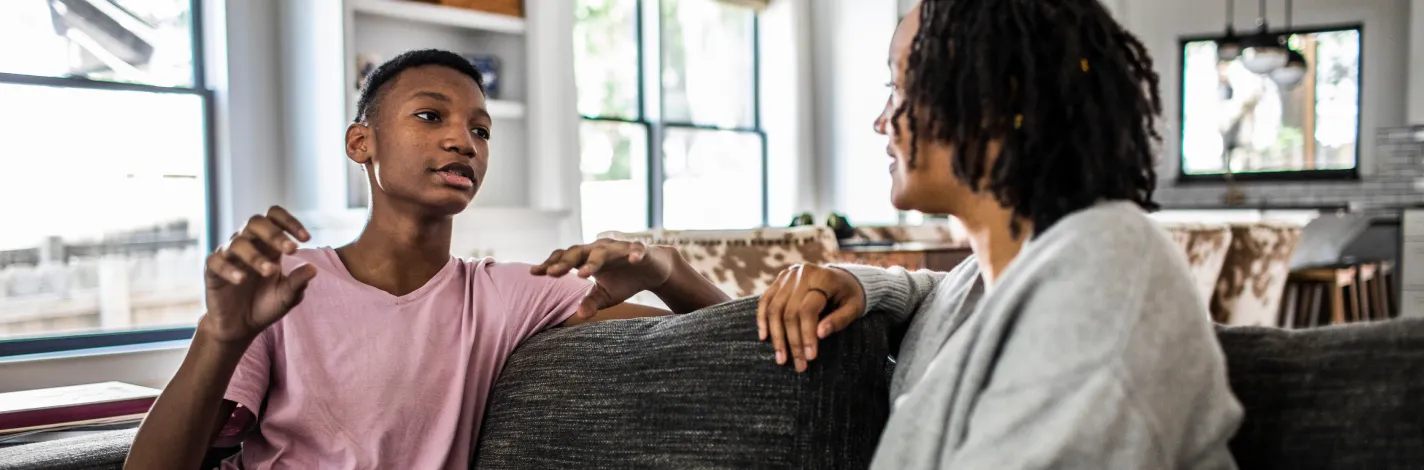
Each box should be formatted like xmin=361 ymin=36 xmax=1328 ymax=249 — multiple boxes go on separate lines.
xmin=0 ymin=0 xmax=212 ymax=356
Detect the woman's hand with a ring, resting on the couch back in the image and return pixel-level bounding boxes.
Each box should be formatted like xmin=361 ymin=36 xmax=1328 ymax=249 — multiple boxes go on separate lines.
xmin=756 ymin=265 xmax=866 ymax=372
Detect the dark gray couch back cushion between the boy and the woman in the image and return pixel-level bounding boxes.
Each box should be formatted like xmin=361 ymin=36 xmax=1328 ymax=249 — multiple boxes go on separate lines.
xmin=476 ymin=298 xmax=890 ymax=469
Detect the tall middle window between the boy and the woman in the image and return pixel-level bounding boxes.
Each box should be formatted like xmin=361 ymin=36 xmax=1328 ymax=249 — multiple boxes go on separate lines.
xmin=574 ymin=0 xmax=766 ymax=239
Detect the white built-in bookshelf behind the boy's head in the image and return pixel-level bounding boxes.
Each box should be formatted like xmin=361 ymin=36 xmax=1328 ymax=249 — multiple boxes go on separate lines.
xmin=279 ymin=0 xmax=580 ymax=254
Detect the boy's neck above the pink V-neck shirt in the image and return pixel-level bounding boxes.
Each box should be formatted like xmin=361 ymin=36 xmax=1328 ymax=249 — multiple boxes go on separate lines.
xmin=336 ymin=202 xmax=453 ymax=296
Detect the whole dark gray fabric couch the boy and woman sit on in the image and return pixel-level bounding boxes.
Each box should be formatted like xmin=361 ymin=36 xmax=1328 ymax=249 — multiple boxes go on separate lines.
xmin=0 ymin=299 xmax=1424 ymax=470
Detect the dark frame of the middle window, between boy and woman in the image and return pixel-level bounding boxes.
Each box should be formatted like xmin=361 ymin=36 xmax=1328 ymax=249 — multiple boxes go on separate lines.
xmin=580 ymin=0 xmax=770 ymax=229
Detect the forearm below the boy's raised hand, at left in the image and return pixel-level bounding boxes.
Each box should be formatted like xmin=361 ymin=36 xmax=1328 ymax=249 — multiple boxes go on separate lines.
xmin=124 ymin=329 xmax=248 ymax=470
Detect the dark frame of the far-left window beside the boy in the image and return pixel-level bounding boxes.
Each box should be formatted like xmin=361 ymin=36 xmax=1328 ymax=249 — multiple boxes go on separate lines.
xmin=0 ymin=0 xmax=219 ymax=360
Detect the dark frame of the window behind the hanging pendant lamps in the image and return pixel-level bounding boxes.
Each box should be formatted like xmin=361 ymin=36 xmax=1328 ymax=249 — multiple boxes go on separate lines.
xmin=1173 ymin=23 xmax=1366 ymax=184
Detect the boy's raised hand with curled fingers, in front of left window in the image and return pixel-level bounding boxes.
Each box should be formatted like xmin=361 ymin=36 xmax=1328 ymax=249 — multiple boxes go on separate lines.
xmin=198 ymin=205 xmax=316 ymax=343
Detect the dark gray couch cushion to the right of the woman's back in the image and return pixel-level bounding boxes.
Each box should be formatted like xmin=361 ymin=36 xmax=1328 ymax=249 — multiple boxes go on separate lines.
xmin=1218 ymin=318 xmax=1424 ymax=469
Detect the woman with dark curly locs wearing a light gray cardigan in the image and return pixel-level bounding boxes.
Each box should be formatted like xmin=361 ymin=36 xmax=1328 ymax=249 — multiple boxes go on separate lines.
xmin=758 ymin=0 xmax=1242 ymax=469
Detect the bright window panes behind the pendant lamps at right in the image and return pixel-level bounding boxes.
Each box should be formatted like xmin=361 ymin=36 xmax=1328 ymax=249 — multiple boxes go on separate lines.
xmin=1182 ymin=27 xmax=1361 ymax=179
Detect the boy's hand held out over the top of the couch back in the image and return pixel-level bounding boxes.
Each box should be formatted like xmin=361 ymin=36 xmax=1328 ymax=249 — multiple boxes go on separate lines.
xmin=530 ymin=238 xmax=681 ymax=319
